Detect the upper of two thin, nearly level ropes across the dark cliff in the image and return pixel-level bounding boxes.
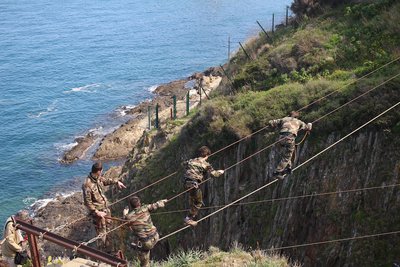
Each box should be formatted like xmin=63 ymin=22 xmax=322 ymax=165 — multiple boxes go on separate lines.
xmin=152 ymin=184 xmax=400 ymax=215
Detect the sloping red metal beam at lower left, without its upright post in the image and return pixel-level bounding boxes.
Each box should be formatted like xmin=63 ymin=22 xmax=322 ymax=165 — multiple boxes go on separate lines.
xmin=16 ymin=219 xmax=127 ymax=267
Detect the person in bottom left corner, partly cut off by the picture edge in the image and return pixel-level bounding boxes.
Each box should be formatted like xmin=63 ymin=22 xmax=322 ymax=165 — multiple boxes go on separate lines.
xmin=1 ymin=210 xmax=29 ymax=267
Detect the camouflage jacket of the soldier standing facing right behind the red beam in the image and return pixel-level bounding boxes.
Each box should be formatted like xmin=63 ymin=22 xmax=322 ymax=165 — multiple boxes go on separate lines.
xmin=82 ymin=173 xmax=118 ymax=214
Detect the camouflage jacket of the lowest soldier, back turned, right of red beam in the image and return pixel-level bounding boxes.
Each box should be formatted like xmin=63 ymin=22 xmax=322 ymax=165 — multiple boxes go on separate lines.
xmin=125 ymin=201 xmax=164 ymax=238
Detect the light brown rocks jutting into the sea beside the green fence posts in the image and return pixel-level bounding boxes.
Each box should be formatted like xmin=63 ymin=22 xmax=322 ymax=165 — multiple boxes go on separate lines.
xmin=60 ymin=67 xmax=221 ymax=164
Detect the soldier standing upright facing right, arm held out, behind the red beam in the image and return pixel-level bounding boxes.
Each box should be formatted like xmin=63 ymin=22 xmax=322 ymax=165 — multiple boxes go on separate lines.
xmin=82 ymin=162 xmax=126 ymax=252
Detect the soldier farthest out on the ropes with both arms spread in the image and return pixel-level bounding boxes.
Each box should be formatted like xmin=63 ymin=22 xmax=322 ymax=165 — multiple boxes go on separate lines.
xmin=269 ymin=111 xmax=312 ymax=179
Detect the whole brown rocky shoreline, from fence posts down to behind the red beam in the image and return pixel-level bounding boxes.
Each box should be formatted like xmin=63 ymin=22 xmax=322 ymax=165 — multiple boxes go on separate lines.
xmin=27 ymin=65 xmax=222 ymax=259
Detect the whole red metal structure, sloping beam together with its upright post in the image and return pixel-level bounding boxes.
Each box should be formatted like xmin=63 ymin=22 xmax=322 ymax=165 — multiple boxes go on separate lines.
xmin=16 ymin=218 xmax=128 ymax=267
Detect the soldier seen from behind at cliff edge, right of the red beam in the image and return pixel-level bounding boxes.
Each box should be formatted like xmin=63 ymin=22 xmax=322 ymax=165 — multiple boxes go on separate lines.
xmin=124 ymin=196 xmax=167 ymax=267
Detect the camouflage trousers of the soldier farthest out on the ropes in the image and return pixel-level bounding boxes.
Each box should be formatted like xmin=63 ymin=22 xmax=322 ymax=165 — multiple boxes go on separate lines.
xmin=275 ymin=134 xmax=296 ymax=172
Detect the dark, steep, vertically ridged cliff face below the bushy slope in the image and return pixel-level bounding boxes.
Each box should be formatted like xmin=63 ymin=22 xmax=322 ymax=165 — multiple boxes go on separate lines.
xmin=156 ymin=129 xmax=400 ymax=266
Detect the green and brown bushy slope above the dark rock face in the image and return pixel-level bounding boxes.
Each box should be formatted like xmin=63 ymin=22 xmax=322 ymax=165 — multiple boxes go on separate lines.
xmin=119 ymin=1 xmax=400 ymax=264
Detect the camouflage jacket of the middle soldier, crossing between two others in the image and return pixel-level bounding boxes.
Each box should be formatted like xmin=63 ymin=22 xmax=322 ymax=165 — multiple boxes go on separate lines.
xmin=183 ymin=157 xmax=221 ymax=182
